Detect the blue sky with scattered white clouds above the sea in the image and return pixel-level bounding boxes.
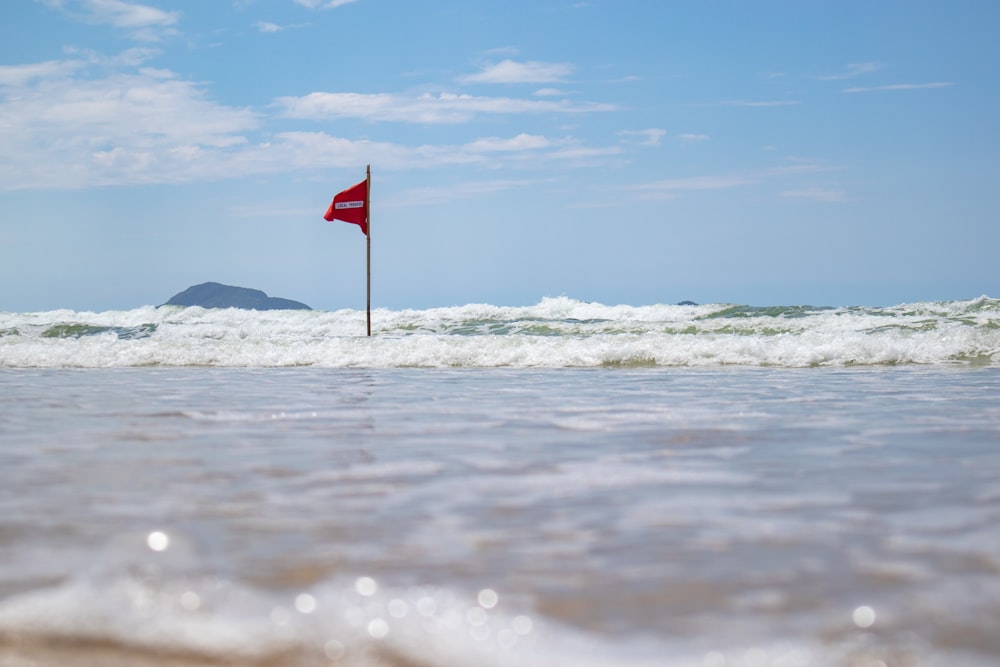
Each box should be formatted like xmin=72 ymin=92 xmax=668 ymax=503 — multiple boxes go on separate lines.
xmin=0 ymin=0 xmax=1000 ymax=311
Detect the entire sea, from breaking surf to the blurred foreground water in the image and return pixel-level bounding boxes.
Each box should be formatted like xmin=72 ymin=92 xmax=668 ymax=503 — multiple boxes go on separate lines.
xmin=0 ymin=296 xmax=1000 ymax=667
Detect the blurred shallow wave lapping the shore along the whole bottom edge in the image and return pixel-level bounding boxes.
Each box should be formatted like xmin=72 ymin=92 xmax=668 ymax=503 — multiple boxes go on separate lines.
xmin=0 ymin=531 xmax=992 ymax=667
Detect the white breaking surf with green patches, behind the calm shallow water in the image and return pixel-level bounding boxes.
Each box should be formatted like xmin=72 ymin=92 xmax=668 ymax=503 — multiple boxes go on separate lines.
xmin=0 ymin=296 xmax=1000 ymax=368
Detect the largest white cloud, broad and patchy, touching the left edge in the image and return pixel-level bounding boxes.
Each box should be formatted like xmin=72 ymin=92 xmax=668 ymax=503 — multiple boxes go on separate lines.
xmin=0 ymin=60 xmax=258 ymax=189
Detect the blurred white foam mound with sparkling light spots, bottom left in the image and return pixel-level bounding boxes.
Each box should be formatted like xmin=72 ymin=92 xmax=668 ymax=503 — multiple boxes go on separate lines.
xmin=0 ymin=563 xmax=680 ymax=667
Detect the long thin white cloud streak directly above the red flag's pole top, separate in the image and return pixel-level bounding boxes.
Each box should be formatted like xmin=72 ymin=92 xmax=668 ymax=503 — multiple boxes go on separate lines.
xmin=275 ymin=93 xmax=617 ymax=124
